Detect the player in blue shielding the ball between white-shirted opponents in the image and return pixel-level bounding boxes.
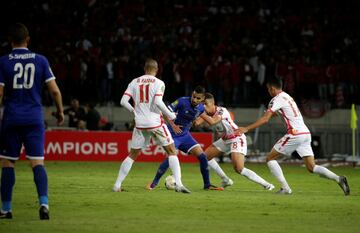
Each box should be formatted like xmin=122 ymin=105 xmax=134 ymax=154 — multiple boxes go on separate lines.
xmin=147 ymin=86 xmax=224 ymax=190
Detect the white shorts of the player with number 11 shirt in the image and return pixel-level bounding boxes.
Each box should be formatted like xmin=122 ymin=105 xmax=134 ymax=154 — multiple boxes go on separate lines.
xmin=131 ymin=124 xmax=174 ymax=149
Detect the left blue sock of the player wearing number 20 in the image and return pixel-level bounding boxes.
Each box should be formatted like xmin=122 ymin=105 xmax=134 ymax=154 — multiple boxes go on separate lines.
xmin=1 ymin=167 xmax=15 ymax=211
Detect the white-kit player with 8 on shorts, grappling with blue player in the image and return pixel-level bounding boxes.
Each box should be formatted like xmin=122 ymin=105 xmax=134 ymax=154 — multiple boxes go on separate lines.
xmin=196 ymin=93 xmax=274 ymax=190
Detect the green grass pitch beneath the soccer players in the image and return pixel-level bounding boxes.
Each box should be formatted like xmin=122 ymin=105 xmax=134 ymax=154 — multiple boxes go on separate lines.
xmin=0 ymin=161 xmax=360 ymax=233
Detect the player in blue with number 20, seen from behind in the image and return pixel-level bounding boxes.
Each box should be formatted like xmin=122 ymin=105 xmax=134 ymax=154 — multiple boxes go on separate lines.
xmin=0 ymin=23 xmax=64 ymax=219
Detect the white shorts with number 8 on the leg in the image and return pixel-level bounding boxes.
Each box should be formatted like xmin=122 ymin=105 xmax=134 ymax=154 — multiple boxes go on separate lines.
xmin=213 ymin=134 xmax=247 ymax=155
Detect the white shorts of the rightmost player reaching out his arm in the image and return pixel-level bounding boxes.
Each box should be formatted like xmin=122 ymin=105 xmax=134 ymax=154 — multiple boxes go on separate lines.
xmin=274 ymin=134 xmax=314 ymax=158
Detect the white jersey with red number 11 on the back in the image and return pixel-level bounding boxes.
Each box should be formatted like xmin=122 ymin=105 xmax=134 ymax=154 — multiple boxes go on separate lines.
xmin=124 ymin=75 xmax=165 ymax=129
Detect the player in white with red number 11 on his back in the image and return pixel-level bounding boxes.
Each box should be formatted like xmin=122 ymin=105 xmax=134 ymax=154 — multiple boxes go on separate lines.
xmin=113 ymin=59 xmax=190 ymax=193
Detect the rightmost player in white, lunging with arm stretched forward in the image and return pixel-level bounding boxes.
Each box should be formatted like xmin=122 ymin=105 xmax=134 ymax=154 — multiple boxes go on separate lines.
xmin=236 ymin=78 xmax=350 ymax=195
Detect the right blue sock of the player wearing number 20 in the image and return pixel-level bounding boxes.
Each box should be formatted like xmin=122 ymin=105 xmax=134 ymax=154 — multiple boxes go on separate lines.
xmin=33 ymin=165 xmax=49 ymax=205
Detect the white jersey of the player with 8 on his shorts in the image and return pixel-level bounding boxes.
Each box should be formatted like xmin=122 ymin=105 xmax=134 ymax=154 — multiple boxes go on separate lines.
xmin=208 ymin=106 xmax=238 ymax=141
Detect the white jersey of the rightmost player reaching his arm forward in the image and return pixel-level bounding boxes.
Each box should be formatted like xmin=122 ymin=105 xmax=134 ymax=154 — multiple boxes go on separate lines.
xmin=268 ymin=92 xmax=310 ymax=135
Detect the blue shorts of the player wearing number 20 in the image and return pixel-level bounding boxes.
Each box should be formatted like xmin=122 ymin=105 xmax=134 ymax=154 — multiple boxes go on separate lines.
xmin=0 ymin=124 xmax=45 ymax=160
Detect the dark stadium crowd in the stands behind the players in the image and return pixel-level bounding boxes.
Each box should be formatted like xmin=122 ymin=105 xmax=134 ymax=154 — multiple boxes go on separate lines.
xmin=0 ymin=0 xmax=360 ymax=108
